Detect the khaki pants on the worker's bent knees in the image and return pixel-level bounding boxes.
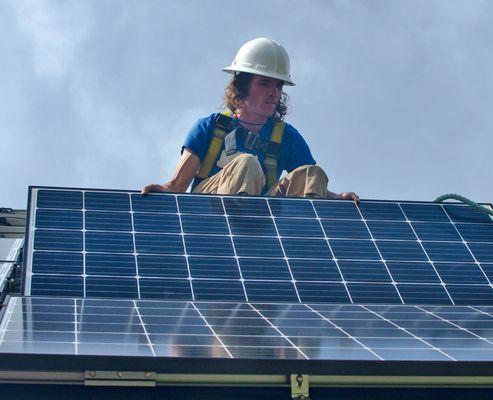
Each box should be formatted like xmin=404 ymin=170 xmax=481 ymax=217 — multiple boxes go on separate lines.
xmin=194 ymin=153 xmax=328 ymax=198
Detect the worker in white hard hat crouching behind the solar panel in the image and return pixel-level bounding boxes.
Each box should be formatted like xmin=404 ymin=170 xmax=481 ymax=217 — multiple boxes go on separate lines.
xmin=142 ymin=38 xmax=359 ymax=202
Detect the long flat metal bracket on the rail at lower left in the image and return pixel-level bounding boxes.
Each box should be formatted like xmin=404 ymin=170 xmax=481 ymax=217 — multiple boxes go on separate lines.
xmin=85 ymin=371 xmax=156 ymax=386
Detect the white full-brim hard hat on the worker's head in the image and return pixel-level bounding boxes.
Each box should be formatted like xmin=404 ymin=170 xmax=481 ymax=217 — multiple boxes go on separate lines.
xmin=223 ymin=38 xmax=295 ymax=86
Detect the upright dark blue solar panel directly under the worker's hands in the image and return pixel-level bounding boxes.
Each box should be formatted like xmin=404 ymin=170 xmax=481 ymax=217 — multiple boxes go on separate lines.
xmin=23 ymin=188 xmax=493 ymax=305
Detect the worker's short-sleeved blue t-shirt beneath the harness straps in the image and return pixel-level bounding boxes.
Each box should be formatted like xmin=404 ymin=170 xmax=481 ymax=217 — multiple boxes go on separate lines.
xmin=182 ymin=113 xmax=316 ymax=192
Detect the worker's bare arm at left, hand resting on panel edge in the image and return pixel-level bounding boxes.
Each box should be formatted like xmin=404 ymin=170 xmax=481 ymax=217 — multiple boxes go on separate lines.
xmin=141 ymin=148 xmax=200 ymax=194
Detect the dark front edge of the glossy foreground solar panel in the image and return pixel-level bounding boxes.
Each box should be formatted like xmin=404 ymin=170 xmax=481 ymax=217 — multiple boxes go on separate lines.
xmin=0 ymin=353 xmax=493 ymax=377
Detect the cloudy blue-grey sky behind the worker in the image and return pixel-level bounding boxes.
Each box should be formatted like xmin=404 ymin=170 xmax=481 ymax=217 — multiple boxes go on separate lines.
xmin=0 ymin=0 xmax=493 ymax=208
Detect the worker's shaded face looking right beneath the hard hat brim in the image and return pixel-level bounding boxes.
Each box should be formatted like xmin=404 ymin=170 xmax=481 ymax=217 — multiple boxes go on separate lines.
xmin=244 ymin=75 xmax=284 ymax=118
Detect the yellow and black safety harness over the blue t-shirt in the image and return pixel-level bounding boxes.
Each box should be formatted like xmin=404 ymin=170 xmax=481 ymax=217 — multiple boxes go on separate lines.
xmin=197 ymin=111 xmax=286 ymax=189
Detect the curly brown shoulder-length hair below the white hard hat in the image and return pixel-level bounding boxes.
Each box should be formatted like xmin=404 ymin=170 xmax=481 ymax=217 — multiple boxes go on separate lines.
xmin=223 ymin=72 xmax=289 ymax=121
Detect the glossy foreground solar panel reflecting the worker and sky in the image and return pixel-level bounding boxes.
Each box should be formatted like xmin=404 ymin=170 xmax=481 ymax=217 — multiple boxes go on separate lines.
xmin=0 ymin=297 xmax=493 ymax=361
